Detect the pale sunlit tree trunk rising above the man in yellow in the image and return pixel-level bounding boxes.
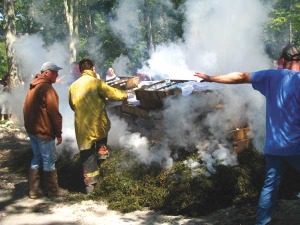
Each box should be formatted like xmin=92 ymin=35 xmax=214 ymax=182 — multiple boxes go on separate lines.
xmin=64 ymin=0 xmax=78 ymax=63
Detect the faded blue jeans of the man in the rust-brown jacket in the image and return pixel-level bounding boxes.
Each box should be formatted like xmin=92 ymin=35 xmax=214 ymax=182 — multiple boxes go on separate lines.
xmin=28 ymin=134 xmax=57 ymax=171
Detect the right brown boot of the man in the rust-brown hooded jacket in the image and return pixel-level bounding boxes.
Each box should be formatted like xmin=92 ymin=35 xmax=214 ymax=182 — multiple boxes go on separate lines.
xmin=44 ymin=170 xmax=69 ymax=198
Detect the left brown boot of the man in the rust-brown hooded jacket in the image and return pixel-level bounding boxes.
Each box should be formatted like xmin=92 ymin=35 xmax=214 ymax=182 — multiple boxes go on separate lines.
xmin=28 ymin=169 xmax=43 ymax=199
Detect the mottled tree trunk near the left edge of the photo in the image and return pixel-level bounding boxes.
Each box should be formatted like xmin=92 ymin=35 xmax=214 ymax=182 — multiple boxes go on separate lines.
xmin=4 ymin=0 xmax=22 ymax=88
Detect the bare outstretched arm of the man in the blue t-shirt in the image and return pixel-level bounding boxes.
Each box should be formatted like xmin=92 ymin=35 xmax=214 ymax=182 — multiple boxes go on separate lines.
xmin=194 ymin=72 xmax=251 ymax=84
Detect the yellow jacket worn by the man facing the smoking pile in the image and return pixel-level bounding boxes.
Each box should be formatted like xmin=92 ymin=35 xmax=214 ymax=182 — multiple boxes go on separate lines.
xmin=69 ymin=70 xmax=127 ymax=150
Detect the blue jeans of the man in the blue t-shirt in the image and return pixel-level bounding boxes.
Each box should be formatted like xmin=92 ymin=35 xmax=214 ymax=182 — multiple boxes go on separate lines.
xmin=256 ymin=155 xmax=300 ymax=225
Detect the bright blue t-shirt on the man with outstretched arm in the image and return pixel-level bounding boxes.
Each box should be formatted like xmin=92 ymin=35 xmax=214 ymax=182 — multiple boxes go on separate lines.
xmin=251 ymin=69 xmax=300 ymax=155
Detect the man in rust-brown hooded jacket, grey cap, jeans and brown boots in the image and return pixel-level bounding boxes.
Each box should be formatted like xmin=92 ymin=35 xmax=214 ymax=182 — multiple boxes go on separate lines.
xmin=23 ymin=62 xmax=66 ymax=199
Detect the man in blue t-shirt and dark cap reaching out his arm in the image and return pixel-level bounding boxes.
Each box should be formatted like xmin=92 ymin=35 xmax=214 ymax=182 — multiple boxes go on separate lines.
xmin=195 ymin=45 xmax=300 ymax=225
